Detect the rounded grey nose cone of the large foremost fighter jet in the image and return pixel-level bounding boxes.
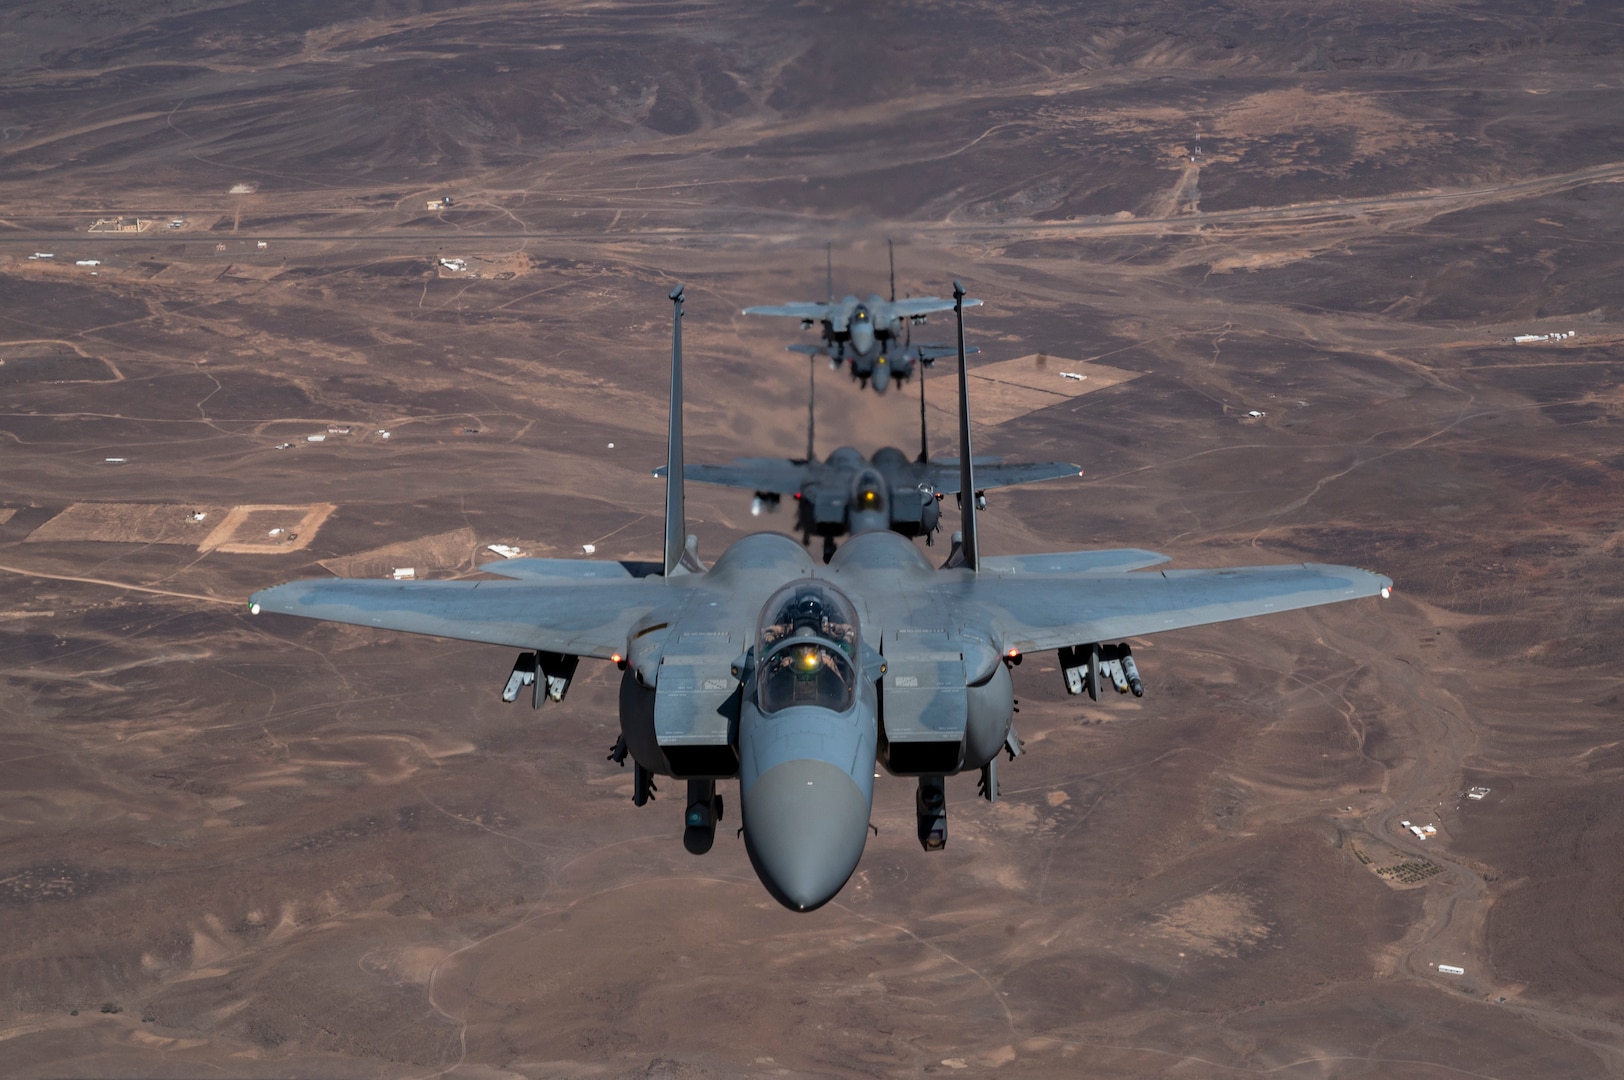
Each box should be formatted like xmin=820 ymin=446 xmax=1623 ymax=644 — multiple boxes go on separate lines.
xmin=744 ymin=760 xmax=869 ymax=911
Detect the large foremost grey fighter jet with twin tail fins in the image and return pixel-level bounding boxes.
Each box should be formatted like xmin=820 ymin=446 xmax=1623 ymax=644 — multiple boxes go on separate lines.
xmin=248 ymin=283 xmax=1390 ymax=911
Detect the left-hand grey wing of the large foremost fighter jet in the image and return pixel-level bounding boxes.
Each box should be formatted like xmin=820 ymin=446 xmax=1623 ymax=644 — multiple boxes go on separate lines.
xmin=248 ymin=578 xmax=669 ymax=659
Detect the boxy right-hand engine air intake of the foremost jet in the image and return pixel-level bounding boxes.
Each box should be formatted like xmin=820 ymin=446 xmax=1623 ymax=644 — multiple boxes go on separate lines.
xmin=880 ymin=629 xmax=970 ymax=773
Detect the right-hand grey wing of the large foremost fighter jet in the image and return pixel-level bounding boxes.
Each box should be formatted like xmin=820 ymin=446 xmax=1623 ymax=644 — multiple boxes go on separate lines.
xmin=937 ymin=552 xmax=1392 ymax=653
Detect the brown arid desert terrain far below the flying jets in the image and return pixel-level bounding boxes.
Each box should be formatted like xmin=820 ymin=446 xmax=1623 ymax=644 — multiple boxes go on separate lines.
xmin=0 ymin=0 xmax=1624 ymax=1080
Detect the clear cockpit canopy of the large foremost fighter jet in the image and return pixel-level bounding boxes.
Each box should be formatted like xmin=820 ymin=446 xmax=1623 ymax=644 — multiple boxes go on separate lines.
xmin=755 ymin=580 xmax=857 ymax=715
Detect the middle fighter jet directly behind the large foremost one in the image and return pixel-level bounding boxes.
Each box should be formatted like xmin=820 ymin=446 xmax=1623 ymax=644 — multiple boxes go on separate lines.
xmin=654 ymin=337 xmax=1083 ymax=562
